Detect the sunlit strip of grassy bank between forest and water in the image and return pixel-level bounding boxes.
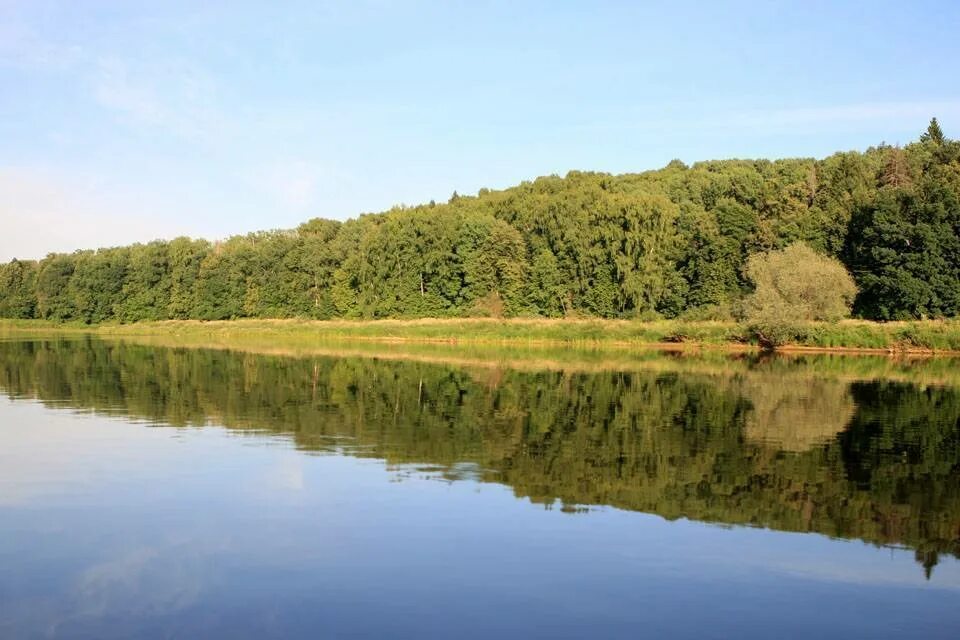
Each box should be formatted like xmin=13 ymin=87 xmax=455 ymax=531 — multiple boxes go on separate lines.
xmin=0 ymin=319 xmax=960 ymax=353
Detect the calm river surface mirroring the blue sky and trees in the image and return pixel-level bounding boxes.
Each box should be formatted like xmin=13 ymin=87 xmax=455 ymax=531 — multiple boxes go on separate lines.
xmin=0 ymin=340 xmax=960 ymax=639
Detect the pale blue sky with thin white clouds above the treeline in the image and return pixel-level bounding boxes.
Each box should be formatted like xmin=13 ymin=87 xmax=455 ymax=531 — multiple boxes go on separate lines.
xmin=0 ymin=0 xmax=960 ymax=261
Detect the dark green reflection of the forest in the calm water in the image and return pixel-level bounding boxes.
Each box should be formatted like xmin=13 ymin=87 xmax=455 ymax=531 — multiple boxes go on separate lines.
xmin=0 ymin=340 xmax=960 ymax=571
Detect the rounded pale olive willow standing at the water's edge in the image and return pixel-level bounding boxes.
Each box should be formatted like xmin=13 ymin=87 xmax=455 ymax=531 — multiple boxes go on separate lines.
xmin=744 ymin=243 xmax=857 ymax=347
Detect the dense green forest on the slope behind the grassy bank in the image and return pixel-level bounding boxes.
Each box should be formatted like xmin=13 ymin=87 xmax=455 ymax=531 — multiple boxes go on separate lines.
xmin=0 ymin=119 xmax=960 ymax=324
